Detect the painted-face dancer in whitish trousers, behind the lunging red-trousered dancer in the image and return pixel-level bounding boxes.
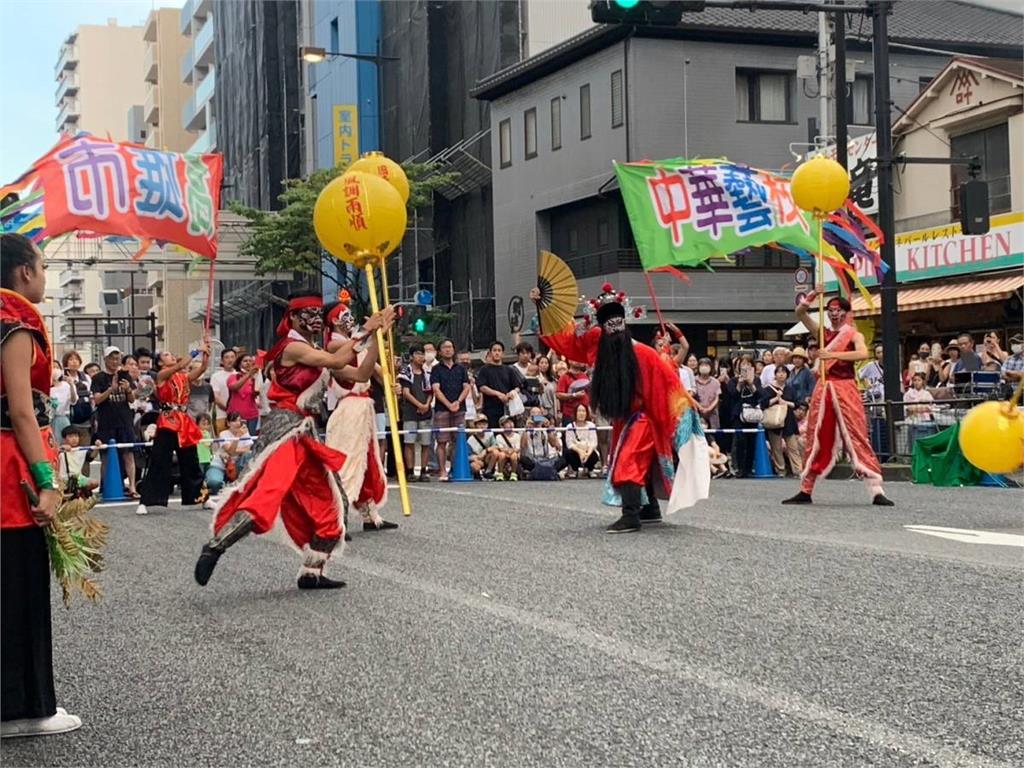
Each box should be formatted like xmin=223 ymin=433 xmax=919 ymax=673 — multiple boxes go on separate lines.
xmin=327 ymin=302 xmax=398 ymax=530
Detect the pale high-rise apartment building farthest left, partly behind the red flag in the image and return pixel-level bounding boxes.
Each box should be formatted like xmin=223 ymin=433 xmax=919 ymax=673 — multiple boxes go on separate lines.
xmin=47 ymin=18 xmax=145 ymax=354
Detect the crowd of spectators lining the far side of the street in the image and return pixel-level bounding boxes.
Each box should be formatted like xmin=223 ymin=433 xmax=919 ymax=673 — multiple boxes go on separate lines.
xmin=50 ymin=329 xmax=1024 ymax=497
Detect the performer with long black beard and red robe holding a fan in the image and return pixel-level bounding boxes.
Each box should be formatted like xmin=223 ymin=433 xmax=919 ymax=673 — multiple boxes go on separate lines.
xmin=529 ymin=284 xmax=711 ymax=534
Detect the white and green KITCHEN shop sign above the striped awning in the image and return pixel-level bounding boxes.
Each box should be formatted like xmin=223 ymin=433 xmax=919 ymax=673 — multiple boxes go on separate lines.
xmin=826 ymin=213 xmax=1024 ymax=288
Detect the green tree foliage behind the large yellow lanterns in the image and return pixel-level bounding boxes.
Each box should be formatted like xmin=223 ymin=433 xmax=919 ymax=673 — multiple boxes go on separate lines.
xmin=228 ymin=162 xmax=459 ymax=301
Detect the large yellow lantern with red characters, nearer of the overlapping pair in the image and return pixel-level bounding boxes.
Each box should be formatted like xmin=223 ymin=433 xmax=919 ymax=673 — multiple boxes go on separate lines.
xmin=313 ymin=171 xmax=408 ymax=267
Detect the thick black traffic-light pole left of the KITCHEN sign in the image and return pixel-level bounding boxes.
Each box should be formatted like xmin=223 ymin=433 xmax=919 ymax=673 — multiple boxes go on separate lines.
xmin=868 ymin=0 xmax=902 ymax=411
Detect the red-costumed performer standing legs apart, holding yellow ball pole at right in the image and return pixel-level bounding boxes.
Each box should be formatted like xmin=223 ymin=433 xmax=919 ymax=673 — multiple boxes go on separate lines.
xmin=782 ymin=286 xmax=893 ymax=507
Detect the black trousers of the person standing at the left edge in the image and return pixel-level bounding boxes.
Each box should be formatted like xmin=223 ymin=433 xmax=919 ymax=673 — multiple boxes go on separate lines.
xmin=0 ymin=525 xmax=57 ymax=720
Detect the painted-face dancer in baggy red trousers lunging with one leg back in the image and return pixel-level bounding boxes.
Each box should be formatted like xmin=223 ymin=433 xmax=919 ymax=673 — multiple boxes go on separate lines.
xmin=196 ymin=295 xmax=394 ymax=589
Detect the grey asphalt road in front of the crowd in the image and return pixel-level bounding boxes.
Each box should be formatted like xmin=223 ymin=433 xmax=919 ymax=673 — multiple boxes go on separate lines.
xmin=0 ymin=480 xmax=1024 ymax=768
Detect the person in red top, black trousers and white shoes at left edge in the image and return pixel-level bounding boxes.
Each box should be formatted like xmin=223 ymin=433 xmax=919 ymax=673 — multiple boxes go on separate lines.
xmin=0 ymin=232 xmax=82 ymax=738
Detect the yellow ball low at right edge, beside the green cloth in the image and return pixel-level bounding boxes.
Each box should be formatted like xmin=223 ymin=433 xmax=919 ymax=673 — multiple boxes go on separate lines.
xmin=959 ymin=400 xmax=1024 ymax=474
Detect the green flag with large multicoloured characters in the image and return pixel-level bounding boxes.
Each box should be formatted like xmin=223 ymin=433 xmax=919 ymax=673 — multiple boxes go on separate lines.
xmin=615 ymin=158 xmax=818 ymax=269
